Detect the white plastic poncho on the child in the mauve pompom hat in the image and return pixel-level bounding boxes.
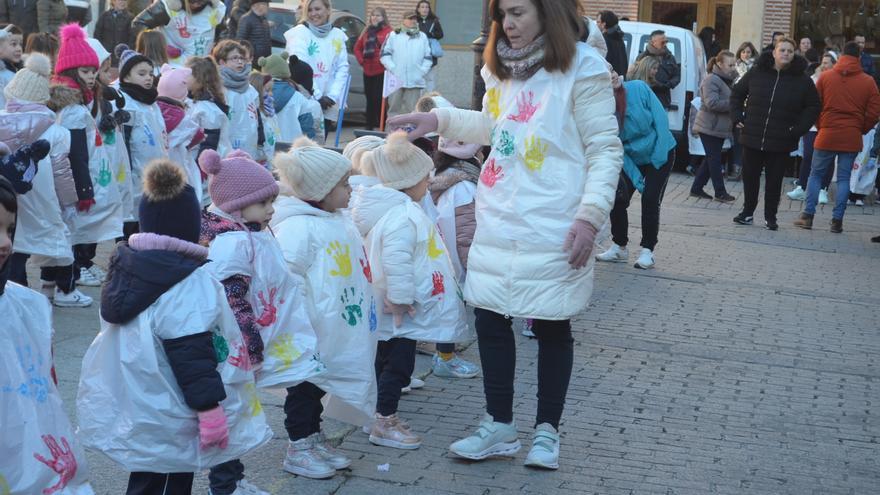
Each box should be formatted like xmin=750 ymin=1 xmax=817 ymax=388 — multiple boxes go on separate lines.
xmin=205 ymin=225 xmax=325 ymax=388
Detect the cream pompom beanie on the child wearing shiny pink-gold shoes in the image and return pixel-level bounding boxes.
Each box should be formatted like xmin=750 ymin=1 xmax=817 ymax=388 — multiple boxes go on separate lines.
xmin=361 ymin=131 xmax=434 ymax=191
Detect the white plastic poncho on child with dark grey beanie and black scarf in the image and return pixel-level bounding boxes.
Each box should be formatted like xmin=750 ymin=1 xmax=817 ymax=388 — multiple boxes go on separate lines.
xmin=120 ymin=90 xmax=168 ymax=220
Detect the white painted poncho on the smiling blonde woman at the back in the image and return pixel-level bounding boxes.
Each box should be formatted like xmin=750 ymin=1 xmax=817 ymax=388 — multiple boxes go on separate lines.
xmin=284 ymin=24 xmax=349 ymax=122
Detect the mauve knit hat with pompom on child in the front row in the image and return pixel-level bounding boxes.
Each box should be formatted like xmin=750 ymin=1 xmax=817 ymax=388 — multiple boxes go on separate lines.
xmin=199 ymin=149 xmax=278 ymax=214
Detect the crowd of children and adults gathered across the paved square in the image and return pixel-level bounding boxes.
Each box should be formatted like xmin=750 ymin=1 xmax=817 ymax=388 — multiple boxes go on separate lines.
xmin=0 ymin=0 xmax=880 ymax=495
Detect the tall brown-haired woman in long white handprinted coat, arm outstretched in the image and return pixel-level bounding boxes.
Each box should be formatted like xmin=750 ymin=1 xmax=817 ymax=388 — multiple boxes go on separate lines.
xmin=388 ymin=0 xmax=623 ymax=469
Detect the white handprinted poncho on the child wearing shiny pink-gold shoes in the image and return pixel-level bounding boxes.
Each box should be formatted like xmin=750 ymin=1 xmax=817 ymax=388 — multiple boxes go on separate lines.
xmin=351 ymin=185 xmax=472 ymax=342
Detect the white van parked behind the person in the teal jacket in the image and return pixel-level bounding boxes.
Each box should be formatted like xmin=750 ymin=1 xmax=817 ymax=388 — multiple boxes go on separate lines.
xmin=620 ymin=21 xmax=706 ymax=139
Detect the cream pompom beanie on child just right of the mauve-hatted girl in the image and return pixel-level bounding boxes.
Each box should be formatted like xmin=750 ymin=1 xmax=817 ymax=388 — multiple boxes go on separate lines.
xmin=274 ymin=137 xmax=351 ymax=201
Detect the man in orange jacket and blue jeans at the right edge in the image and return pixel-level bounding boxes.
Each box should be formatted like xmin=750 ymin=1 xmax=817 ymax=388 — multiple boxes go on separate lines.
xmin=794 ymin=41 xmax=880 ymax=233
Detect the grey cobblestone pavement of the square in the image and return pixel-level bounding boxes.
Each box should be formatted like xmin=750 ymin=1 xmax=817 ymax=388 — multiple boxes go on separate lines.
xmin=48 ymin=175 xmax=880 ymax=495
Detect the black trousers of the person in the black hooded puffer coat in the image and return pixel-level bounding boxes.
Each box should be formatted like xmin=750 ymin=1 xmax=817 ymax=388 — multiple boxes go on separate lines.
xmin=743 ymin=146 xmax=791 ymax=222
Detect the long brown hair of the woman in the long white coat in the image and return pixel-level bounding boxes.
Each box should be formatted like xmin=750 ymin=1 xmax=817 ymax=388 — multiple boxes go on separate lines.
xmin=483 ymin=0 xmax=586 ymax=81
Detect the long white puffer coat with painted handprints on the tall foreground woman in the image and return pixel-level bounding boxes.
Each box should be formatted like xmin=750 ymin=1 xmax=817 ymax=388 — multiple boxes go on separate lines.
xmin=433 ymin=43 xmax=623 ymax=320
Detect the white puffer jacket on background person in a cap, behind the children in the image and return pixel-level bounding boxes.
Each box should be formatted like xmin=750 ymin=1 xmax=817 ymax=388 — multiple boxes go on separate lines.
xmin=380 ymin=32 xmax=433 ymax=88
